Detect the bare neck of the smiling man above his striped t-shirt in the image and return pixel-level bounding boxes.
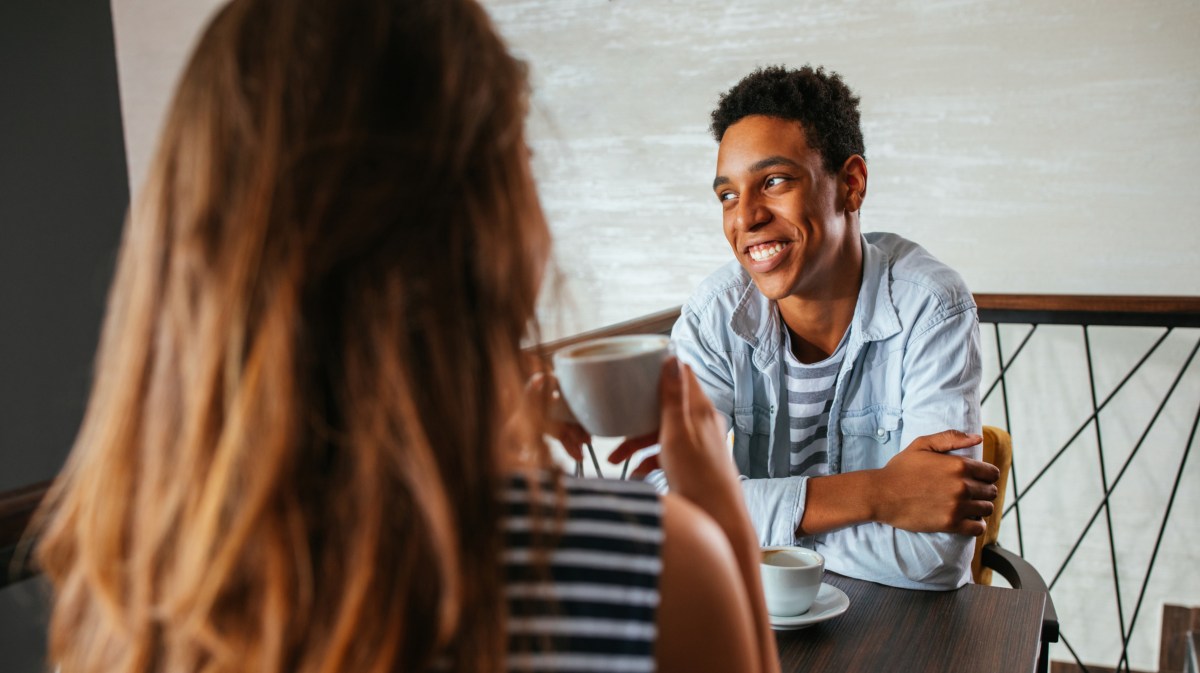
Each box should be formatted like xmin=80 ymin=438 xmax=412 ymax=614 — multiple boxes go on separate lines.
xmin=779 ymin=238 xmax=863 ymax=363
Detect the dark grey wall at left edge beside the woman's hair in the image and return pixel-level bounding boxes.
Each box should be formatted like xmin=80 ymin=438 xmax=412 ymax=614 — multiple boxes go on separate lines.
xmin=0 ymin=0 xmax=130 ymax=673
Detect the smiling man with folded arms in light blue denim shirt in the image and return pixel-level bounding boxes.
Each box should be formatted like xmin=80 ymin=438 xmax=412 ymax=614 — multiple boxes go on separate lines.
xmin=672 ymin=67 xmax=998 ymax=589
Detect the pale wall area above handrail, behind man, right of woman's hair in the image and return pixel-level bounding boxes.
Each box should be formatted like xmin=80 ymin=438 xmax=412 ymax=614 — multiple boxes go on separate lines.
xmin=486 ymin=0 xmax=1200 ymax=331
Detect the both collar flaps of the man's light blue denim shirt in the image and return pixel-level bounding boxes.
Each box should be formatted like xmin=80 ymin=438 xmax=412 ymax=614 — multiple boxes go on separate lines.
xmin=730 ymin=236 xmax=900 ymax=369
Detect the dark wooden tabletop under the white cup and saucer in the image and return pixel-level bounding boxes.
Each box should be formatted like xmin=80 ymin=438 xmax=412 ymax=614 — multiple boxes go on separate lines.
xmin=775 ymin=572 xmax=1045 ymax=673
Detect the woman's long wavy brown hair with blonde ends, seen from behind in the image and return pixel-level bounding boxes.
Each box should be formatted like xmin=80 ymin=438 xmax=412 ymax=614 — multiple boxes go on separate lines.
xmin=37 ymin=0 xmax=550 ymax=673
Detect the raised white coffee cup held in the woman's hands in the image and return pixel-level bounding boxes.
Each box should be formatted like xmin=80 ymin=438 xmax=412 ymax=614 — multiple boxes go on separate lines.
xmin=554 ymin=335 xmax=672 ymax=437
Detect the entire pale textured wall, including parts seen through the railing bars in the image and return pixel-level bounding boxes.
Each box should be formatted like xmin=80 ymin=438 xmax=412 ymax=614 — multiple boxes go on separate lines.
xmin=113 ymin=0 xmax=1200 ymax=671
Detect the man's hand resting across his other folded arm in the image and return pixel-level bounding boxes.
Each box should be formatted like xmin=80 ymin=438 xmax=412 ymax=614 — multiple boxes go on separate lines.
xmin=872 ymin=429 xmax=1000 ymax=536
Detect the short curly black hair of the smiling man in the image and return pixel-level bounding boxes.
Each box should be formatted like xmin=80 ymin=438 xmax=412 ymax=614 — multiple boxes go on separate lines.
xmin=712 ymin=66 xmax=866 ymax=173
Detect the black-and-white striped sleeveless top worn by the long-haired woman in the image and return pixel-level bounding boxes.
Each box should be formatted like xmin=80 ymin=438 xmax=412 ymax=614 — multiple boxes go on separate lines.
xmin=503 ymin=477 xmax=662 ymax=672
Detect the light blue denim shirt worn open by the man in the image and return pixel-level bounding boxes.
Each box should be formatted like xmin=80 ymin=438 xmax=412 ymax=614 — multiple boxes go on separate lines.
xmin=672 ymin=233 xmax=980 ymax=589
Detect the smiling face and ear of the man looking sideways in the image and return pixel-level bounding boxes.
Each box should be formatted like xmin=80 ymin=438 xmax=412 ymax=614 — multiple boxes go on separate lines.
xmin=713 ymin=115 xmax=865 ymax=301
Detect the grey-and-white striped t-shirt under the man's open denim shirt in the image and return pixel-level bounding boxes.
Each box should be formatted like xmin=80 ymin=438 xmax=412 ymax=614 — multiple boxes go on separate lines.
xmin=784 ymin=328 xmax=848 ymax=476
